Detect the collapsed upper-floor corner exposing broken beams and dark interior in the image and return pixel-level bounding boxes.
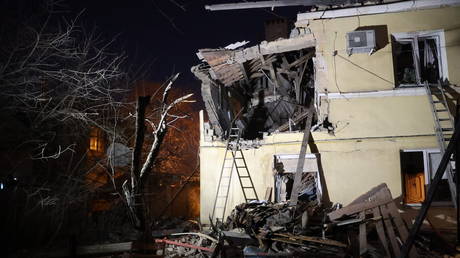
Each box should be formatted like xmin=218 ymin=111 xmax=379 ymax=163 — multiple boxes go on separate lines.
xmin=192 ymin=33 xmax=315 ymax=139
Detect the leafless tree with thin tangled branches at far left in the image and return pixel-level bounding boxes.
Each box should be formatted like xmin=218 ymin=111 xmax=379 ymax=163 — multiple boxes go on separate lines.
xmin=0 ymin=2 xmax=129 ymax=251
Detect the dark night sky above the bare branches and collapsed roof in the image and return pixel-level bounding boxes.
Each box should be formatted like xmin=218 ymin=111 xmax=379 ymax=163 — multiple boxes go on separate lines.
xmin=65 ymin=0 xmax=302 ymax=88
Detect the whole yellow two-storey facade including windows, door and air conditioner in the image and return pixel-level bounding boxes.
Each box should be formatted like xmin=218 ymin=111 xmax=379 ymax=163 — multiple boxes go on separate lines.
xmin=195 ymin=0 xmax=460 ymax=222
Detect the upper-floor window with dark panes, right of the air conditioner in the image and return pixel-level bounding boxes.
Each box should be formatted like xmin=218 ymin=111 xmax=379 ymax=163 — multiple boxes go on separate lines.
xmin=393 ymin=31 xmax=447 ymax=86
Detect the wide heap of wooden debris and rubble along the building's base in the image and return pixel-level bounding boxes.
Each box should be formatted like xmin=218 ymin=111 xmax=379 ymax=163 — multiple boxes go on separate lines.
xmin=156 ymin=184 xmax=450 ymax=257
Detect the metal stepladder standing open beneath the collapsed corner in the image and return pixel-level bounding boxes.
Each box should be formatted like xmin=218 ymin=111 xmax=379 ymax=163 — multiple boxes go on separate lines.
xmin=211 ymin=128 xmax=259 ymax=221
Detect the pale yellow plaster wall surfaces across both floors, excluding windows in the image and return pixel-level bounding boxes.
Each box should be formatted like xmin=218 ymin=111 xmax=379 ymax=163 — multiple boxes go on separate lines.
xmin=200 ymin=7 xmax=460 ymax=223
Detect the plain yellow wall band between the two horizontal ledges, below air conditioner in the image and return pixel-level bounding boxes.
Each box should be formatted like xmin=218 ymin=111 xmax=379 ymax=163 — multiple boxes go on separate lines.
xmin=329 ymin=95 xmax=434 ymax=138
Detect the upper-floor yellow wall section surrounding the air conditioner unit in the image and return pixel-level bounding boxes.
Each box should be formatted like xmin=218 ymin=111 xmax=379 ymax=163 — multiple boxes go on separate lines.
xmin=308 ymin=7 xmax=460 ymax=92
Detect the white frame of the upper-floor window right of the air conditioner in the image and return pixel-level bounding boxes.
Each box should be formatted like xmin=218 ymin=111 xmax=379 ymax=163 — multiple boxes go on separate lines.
xmin=392 ymin=30 xmax=448 ymax=87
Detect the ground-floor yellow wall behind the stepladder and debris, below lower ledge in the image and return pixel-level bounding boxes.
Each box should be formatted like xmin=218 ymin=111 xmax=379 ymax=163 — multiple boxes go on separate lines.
xmin=200 ymin=130 xmax=436 ymax=223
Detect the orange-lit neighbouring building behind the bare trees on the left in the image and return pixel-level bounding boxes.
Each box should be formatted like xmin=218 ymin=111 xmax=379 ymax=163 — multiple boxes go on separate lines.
xmin=85 ymin=81 xmax=200 ymax=219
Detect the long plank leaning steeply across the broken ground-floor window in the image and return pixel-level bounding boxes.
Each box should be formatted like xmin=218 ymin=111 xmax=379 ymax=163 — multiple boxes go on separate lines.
xmin=289 ymin=101 xmax=314 ymax=206
